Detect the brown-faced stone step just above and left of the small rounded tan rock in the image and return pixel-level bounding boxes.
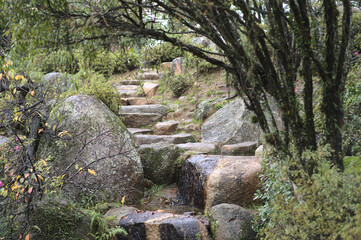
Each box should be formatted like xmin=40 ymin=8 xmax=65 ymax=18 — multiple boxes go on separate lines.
xmin=119 ymin=113 xmax=163 ymax=128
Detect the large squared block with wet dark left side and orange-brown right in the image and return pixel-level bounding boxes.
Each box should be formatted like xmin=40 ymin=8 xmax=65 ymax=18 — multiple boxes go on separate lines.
xmin=178 ymin=155 xmax=261 ymax=209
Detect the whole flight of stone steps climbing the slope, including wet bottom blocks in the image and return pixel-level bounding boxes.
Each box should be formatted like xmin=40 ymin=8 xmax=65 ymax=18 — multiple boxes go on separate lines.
xmin=111 ymin=66 xmax=260 ymax=239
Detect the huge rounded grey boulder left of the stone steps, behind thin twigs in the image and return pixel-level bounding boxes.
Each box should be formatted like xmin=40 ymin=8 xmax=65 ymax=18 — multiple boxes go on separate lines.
xmin=37 ymin=95 xmax=143 ymax=202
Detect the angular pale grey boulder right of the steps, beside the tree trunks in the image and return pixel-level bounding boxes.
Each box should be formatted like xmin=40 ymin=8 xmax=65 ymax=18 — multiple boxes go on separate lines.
xmin=202 ymin=99 xmax=261 ymax=144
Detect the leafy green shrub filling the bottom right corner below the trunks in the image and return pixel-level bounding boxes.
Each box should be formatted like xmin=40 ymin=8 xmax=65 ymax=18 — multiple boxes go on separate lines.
xmin=256 ymin=147 xmax=361 ymax=239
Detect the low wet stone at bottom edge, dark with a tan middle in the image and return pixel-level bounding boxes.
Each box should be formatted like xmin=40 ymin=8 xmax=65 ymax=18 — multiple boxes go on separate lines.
xmin=118 ymin=211 xmax=211 ymax=240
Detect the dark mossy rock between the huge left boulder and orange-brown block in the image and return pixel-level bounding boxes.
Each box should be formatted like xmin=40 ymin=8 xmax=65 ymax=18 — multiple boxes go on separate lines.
xmin=138 ymin=143 xmax=180 ymax=184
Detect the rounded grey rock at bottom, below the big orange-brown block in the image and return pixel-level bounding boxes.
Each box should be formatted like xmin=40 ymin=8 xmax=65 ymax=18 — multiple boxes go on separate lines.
xmin=209 ymin=203 xmax=257 ymax=240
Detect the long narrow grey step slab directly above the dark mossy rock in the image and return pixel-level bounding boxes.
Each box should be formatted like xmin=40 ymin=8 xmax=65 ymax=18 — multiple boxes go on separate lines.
xmin=134 ymin=133 xmax=196 ymax=146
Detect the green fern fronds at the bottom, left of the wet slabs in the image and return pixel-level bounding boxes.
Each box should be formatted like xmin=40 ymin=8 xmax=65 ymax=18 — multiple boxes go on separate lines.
xmin=88 ymin=211 xmax=128 ymax=240
